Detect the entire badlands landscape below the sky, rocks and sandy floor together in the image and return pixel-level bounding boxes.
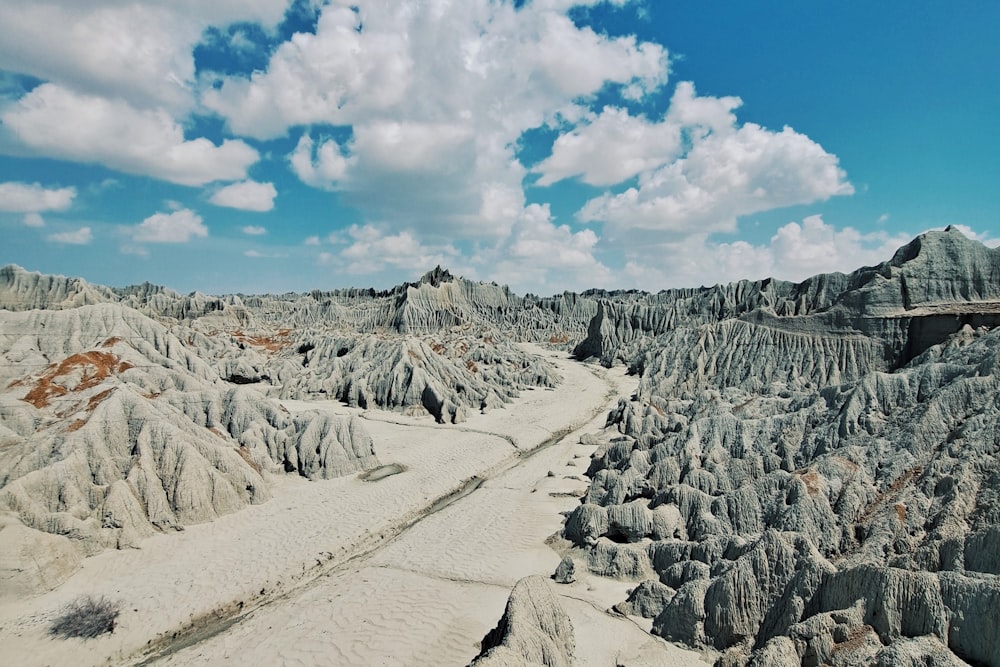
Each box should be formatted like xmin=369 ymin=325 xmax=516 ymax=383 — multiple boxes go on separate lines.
xmin=0 ymin=228 xmax=1000 ymax=667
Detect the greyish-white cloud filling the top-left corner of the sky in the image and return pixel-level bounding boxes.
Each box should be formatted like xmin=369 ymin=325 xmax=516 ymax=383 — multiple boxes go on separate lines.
xmin=0 ymin=0 xmax=287 ymax=112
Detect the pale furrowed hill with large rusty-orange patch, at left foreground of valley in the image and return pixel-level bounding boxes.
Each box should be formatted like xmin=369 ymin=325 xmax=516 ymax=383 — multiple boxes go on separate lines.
xmin=0 ymin=303 xmax=379 ymax=556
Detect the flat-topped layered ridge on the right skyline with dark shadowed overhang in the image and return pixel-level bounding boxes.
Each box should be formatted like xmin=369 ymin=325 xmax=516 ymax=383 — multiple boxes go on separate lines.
xmin=574 ymin=227 xmax=1000 ymax=368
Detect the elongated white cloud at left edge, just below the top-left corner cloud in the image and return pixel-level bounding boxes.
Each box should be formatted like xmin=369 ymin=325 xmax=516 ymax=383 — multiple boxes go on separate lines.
xmin=0 ymin=83 xmax=259 ymax=185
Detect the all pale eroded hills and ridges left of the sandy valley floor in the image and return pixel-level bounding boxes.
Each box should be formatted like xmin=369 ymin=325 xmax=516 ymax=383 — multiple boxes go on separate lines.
xmin=0 ymin=266 xmax=584 ymax=591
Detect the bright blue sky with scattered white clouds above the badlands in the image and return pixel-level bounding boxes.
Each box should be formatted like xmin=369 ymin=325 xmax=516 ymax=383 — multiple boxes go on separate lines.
xmin=0 ymin=0 xmax=1000 ymax=294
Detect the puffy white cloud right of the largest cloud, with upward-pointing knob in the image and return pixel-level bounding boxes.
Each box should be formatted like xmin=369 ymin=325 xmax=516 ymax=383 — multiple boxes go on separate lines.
xmin=578 ymin=84 xmax=854 ymax=236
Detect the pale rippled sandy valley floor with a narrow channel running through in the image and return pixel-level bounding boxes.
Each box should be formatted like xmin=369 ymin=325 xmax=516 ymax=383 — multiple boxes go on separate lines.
xmin=0 ymin=348 xmax=704 ymax=665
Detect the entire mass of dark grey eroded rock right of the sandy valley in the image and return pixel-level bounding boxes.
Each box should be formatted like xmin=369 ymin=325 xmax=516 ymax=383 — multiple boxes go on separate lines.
xmin=564 ymin=229 xmax=1000 ymax=665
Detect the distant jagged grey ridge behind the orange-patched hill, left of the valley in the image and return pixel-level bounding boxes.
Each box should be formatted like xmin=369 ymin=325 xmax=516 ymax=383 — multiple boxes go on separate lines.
xmin=0 ymin=267 xmax=576 ymax=422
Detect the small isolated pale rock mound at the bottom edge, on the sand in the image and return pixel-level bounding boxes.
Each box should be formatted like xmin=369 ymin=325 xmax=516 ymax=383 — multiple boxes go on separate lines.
xmin=471 ymin=575 xmax=575 ymax=667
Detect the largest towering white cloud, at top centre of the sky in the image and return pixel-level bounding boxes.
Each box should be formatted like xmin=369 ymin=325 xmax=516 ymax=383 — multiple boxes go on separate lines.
xmin=209 ymin=0 xmax=668 ymax=239
